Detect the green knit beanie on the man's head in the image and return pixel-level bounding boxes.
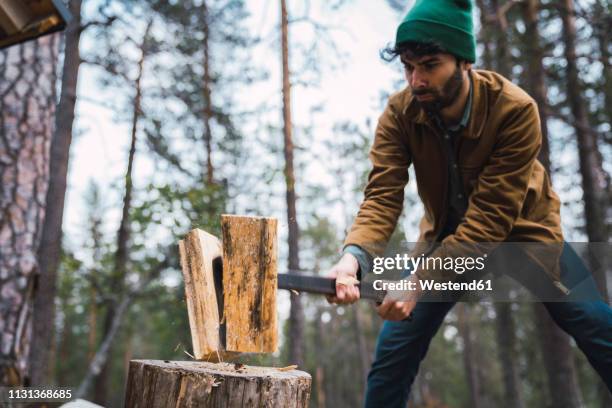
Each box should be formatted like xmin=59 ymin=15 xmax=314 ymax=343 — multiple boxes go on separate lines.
xmin=395 ymin=0 xmax=476 ymax=62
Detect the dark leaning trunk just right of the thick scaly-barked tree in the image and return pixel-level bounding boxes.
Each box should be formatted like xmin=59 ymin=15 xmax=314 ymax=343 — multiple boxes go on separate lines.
xmin=30 ymin=0 xmax=81 ymax=385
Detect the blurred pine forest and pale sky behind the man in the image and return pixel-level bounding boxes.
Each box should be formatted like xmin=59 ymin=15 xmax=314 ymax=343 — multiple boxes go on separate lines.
xmin=0 ymin=0 xmax=612 ymax=408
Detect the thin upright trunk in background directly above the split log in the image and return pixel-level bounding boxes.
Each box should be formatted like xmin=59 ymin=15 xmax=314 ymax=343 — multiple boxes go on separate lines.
xmin=202 ymin=1 xmax=214 ymax=185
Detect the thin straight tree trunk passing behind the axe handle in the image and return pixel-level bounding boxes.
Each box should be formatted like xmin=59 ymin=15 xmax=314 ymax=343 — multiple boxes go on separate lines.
xmin=280 ymin=0 xmax=304 ymax=366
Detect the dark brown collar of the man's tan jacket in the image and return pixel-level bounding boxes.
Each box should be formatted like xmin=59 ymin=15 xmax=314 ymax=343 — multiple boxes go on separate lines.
xmin=404 ymin=69 xmax=489 ymax=139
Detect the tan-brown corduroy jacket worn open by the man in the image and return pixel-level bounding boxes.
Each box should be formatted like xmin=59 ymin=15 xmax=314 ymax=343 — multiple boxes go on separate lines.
xmin=344 ymin=70 xmax=563 ymax=281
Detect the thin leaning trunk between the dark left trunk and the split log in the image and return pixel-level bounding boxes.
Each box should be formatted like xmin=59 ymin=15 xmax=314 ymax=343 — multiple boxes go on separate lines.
xmin=92 ymin=21 xmax=152 ymax=405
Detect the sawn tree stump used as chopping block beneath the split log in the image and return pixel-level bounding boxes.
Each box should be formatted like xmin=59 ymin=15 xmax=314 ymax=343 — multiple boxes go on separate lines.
xmin=125 ymin=360 xmax=311 ymax=408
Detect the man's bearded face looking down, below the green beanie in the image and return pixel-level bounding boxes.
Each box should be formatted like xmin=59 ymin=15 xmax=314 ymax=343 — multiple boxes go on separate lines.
xmin=401 ymin=54 xmax=464 ymax=114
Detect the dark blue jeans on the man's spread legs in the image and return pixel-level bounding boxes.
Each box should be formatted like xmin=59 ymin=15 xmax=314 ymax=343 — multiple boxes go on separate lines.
xmin=365 ymin=243 xmax=612 ymax=408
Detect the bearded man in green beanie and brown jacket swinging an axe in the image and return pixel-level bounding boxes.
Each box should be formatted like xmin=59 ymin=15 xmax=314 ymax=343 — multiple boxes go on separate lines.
xmin=328 ymin=0 xmax=612 ymax=408
